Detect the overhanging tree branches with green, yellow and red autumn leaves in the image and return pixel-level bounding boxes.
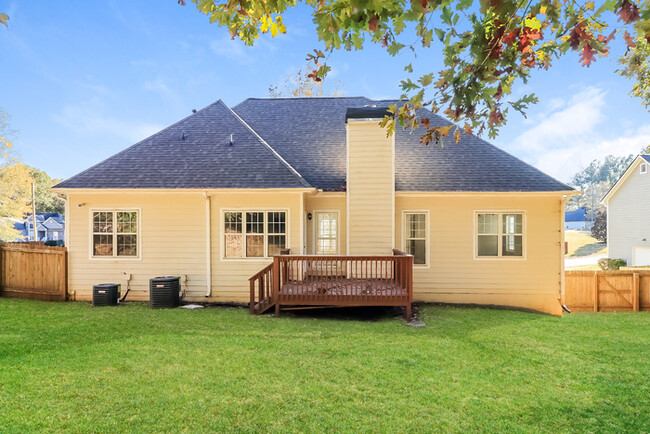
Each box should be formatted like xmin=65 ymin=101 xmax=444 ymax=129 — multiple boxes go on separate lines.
xmin=178 ymin=0 xmax=650 ymax=144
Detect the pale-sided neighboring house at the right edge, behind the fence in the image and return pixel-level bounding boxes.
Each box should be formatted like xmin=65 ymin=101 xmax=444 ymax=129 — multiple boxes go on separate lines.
xmin=603 ymin=155 xmax=650 ymax=266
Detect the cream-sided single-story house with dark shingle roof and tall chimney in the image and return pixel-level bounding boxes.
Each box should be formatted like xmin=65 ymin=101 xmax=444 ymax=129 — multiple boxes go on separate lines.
xmin=55 ymin=97 xmax=575 ymax=314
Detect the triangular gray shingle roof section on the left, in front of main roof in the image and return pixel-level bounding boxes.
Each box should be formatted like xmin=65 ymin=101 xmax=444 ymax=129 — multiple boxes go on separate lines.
xmin=56 ymin=100 xmax=310 ymax=188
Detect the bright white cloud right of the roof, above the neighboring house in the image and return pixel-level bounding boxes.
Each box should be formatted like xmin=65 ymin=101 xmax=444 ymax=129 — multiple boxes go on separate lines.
xmin=506 ymin=88 xmax=650 ymax=182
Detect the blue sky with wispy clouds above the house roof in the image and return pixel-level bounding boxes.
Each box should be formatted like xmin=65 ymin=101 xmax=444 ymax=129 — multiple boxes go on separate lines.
xmin=0 ymin=0 xmax=650 ymax=181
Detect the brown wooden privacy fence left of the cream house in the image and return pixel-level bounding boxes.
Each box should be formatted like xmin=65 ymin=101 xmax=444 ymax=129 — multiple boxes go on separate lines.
xmin=0 ymin=243 xmax=68 ymax=301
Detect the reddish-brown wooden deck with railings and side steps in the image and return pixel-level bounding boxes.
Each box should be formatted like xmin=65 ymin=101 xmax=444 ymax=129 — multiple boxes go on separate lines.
xmin=249 ymin=250 xmax=413 ymax=321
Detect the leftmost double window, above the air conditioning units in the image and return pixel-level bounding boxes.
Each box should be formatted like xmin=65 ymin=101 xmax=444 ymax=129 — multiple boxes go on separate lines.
xmin=92 ymin=211 xmax=138 ymax=257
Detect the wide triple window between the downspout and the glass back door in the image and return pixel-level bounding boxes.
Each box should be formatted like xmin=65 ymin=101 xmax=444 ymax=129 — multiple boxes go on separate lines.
xmin=223 ymin=210 xmax=287 ymax=258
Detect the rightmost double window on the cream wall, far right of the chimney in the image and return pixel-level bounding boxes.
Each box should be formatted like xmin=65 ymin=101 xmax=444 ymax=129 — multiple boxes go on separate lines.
xmin=476 ymin=212 xmax=524 ymax=258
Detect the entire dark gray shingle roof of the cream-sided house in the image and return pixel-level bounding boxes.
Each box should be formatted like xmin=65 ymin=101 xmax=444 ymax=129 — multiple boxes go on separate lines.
xmin=57 ymin=97 xmax=572 ymax=192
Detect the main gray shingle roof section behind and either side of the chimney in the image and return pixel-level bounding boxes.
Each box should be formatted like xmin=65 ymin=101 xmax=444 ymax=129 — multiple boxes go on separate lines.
xmin=233 ymin=97 xmax=573 ymax=192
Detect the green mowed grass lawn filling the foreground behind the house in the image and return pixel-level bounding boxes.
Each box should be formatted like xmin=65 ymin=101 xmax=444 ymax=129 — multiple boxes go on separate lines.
xmin=0 ymin=299 xmax=650 ymax=433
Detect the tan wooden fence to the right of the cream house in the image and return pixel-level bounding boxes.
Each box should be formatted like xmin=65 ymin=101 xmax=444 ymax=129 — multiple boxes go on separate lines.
xmin=564 ymin=270 xmax=650 ymax=312
